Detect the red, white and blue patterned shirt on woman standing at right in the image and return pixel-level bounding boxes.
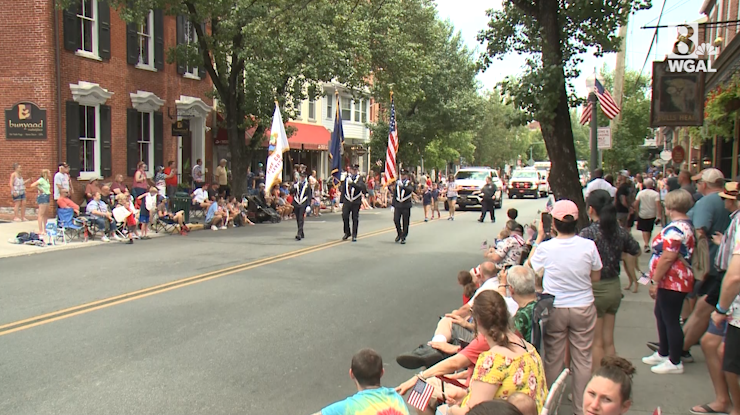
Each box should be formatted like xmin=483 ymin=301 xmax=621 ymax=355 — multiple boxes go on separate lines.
xmin=650 ymin=220 xmax=696 ymax=293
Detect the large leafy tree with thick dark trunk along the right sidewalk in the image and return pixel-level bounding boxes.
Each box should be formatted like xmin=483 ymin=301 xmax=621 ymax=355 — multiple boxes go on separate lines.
xmin=479 ymin=0 xmax=650 ymax=223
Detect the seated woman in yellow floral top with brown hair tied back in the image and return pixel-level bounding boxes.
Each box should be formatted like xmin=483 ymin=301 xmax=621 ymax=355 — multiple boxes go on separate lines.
xmin=447 ymin=290 xmax=547 ymax=415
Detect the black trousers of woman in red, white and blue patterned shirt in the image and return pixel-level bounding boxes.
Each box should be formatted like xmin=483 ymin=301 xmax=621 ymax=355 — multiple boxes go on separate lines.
xmin=654 ymin=288 xmax=687 ymax=365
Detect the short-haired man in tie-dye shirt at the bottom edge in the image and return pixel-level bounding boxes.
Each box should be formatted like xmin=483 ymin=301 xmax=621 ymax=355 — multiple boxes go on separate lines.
xmin=315 ymin=349 xmax=409 ymax=415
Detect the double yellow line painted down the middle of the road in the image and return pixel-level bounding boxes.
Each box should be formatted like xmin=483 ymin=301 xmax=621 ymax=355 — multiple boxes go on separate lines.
xmin=0 ymin=221 xmax=424 ymax=336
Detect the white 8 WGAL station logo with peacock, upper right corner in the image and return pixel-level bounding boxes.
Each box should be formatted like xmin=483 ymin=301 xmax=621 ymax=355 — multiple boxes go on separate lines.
xmin=667 ymin=23 xmax=719 ymax=72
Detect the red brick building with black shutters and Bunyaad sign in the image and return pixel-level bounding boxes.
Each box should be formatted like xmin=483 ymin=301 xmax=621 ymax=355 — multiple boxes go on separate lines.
xmin=0 ymin=0 xmax=214 ymax=211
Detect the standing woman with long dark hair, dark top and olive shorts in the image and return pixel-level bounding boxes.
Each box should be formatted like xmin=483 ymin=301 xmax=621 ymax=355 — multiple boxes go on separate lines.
xmin=581 ymin=189 xmax=640 ymax=370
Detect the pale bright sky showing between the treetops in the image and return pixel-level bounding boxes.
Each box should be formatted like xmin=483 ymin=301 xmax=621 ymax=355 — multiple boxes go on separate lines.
xmin=437 ymin=0 xmax=703 ymax=96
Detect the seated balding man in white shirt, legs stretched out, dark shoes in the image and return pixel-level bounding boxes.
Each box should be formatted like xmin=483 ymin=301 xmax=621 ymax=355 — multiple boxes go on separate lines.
xmin=396 ymin=262 xmax=519 ymax=369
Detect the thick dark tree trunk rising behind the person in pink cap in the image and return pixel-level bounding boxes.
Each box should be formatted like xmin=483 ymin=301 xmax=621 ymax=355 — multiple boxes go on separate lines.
xmin=538 ymin=1 xmax=588 ymax=227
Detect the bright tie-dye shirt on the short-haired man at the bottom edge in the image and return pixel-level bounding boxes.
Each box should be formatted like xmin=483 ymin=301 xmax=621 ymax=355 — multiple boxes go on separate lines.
xmin=321 ymin=388 xmax=409 ymax=415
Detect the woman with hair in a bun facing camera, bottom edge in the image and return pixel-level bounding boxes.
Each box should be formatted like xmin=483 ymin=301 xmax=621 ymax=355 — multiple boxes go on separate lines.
xmin=583 ymin=356 xmax=632 ymax=415
